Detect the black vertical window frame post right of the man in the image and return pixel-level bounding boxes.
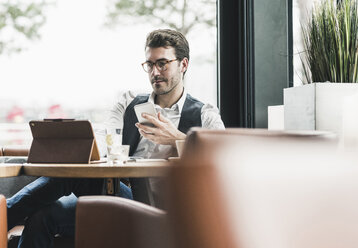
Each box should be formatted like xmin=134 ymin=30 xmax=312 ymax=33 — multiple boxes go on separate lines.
xmin=217 ymin=0 xmax=255 ymax=127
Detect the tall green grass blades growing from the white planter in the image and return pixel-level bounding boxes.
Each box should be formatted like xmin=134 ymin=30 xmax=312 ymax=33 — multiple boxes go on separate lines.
xmin=301 ymin=0 xmax=358 ymax=83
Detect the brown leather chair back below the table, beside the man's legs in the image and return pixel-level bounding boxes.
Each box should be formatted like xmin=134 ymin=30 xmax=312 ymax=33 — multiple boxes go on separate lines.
xmin=75 ymin=196 xmax=171 ymax=248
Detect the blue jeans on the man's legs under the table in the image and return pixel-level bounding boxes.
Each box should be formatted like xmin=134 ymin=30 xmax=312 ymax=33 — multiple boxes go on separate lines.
xmin=7 ymin=177 xmax=132 ymax=247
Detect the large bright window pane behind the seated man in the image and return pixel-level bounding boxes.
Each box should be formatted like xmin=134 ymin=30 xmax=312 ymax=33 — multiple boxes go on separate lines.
xmin=0 ymin=0 xmax=217 ymax=146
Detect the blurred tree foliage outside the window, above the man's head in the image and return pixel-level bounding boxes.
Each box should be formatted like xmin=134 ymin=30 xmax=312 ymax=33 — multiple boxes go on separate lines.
xmin=106 ymin=0 xmax=216 ymax=35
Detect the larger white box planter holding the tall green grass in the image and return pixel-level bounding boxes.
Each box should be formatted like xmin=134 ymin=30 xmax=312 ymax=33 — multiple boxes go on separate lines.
xmin=284 ymin=83 xmax=358 ymax=133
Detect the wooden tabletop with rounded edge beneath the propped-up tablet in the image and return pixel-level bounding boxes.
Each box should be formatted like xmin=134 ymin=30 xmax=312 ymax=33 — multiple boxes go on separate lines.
xmin=23 ymin=160 xmax=169 ymax=178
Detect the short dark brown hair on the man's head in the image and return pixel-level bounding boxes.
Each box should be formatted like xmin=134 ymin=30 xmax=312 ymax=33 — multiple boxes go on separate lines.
xmin=145 ymin=29 xmax=189 ymax=61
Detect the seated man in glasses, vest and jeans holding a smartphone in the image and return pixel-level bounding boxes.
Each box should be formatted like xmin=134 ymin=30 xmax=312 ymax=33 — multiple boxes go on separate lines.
xmin=7 ymin=30 xmax=224 ymax=247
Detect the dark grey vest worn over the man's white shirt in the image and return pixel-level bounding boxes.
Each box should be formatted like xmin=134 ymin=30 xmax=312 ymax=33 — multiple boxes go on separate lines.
xmin=123 ymin=94 xmax=204 ymax=204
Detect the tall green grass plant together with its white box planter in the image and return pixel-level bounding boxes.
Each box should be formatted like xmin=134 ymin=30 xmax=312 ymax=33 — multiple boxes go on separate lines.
xmin=284 ymin=0 xmax=358 ymax=132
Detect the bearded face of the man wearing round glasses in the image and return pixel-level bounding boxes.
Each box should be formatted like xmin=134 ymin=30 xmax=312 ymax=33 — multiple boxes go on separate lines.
xmin=145 ymin=47 xmax=186 ymax=95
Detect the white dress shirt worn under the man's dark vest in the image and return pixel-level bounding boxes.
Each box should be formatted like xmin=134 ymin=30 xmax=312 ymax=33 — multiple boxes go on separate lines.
xmin=107 ymin=90 xmax=225 ymax=158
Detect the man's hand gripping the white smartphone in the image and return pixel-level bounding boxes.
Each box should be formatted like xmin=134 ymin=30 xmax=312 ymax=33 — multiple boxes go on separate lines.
xmin=135 ymin=113 xmax=186 ymax=146
